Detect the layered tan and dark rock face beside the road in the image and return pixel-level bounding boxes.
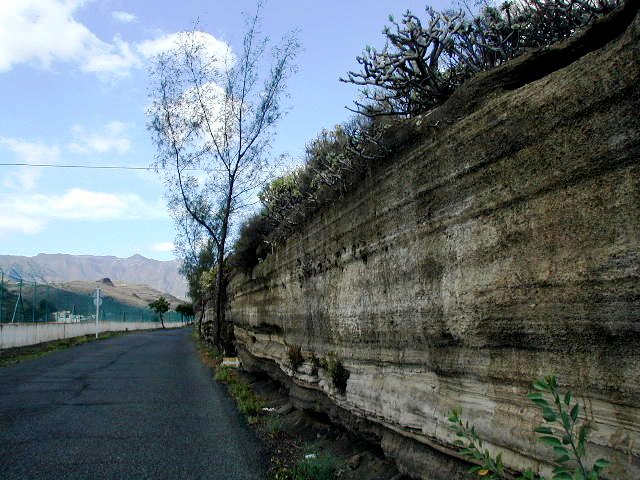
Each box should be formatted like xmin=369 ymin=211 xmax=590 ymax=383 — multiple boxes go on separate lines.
xmin=228 ymin=7 xmax=640 ymax=480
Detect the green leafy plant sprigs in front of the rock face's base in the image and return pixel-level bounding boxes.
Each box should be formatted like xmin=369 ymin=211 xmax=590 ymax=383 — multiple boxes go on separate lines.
xmin=448 ymin=375 xmax=610 ymax=480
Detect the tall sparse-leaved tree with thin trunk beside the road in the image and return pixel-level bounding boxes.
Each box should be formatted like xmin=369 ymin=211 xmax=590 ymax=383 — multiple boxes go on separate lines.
xmin=148 ymin=4 xmax=299 ymax=346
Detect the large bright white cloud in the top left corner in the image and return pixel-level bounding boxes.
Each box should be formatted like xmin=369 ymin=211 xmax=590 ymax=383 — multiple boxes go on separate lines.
xmin=0 ymin=0 xmax=140 ymax=75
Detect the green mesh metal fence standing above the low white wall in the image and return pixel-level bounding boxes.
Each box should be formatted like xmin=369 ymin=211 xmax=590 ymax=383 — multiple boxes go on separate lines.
xmin=0 ymin=270 xmax=184 ymax=323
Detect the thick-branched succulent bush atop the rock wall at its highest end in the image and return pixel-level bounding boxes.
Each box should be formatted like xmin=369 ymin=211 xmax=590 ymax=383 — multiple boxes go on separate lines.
xmin=341 ymin=0 xmax=620 ymax=117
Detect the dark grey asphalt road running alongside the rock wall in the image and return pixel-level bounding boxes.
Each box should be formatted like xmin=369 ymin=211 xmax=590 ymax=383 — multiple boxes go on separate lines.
xmin=0 ymin=329 xmax=267 ymax=480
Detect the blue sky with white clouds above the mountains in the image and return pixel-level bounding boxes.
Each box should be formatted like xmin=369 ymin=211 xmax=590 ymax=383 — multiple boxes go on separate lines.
xmin=0 ymin=0 xmax=446 ymax=260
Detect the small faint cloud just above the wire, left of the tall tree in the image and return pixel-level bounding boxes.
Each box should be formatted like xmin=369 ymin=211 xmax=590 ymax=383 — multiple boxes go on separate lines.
xmin=68 ymin=122 xmax=131 ymax=154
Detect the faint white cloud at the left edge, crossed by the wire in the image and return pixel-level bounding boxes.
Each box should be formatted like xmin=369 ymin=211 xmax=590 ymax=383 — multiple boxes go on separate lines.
xmin=0 ymin=137 xmax=60 ymax=190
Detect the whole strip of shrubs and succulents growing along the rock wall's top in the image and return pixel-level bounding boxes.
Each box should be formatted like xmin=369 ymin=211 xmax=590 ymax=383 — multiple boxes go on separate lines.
xmin=230 ymin=0 xmax=621 ymax=273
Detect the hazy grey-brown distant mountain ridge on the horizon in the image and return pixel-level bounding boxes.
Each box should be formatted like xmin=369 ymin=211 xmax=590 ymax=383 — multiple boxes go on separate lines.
xmin=0 ymin=253 xmax=187 ymax=299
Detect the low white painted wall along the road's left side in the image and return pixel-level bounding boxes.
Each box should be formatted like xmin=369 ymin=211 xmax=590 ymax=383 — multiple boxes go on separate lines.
xmin=0 ymin=321 xmax=186 ymax=350
